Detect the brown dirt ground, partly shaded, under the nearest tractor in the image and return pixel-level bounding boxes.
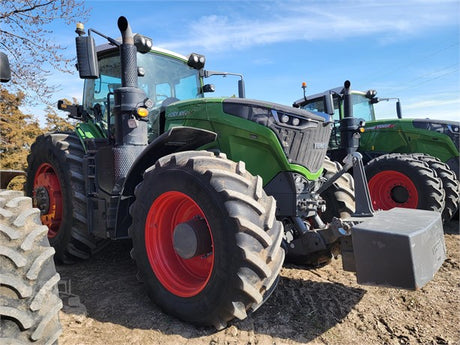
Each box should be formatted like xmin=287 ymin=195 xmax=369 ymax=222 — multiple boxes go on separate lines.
xmin=57 ymin=221 xmax=460 ymax=345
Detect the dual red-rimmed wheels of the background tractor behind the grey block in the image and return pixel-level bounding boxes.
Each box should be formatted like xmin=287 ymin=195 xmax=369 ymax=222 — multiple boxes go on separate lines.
xmin=365 ymin=153 xmax=459 ymax=222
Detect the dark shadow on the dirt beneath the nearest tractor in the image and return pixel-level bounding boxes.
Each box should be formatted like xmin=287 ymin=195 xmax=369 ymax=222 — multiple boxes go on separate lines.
xmin=57 ymin=241 xmax=365 ymax=342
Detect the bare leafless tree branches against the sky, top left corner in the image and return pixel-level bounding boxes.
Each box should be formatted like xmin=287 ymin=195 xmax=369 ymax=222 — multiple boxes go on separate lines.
xmin=0 ymin=0 xmax=89 ymax=103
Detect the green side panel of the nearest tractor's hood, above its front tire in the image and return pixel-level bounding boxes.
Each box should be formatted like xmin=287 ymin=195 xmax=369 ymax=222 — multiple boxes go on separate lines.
xmin=166 ymin=98 xmax=322 ymax=184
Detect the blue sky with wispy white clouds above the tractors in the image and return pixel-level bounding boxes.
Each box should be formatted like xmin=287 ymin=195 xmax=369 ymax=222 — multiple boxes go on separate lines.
xmin=31 ymin=0 xmax=460 ymax=121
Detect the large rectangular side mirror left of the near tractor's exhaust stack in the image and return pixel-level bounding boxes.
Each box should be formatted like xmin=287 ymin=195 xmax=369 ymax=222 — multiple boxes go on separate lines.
xmin=75 ymin=36 xmax=99 ymax=79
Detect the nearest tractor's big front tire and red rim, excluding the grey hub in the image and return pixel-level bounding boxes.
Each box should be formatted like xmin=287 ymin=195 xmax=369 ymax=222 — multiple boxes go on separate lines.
xmin=130 ymin=151 xmax=284 ymax=329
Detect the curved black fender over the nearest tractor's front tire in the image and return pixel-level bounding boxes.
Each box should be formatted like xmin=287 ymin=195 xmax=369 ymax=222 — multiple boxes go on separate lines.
xmin=114 ymin=126 xmax=217 ymax=239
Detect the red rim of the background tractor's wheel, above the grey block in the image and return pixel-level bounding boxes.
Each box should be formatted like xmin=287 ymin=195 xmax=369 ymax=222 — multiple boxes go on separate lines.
xmin=369 ymin=170 xmax=418 ymax=210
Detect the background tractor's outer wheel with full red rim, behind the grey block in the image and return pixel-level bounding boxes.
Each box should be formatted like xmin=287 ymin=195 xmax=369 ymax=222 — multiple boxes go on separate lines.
xmin=365 ymin=154 xmax=445 ymax=213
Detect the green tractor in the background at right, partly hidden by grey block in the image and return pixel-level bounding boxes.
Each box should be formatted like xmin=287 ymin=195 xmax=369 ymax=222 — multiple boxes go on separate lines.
xmin=294 ymin=87 xmax=460 ymax=222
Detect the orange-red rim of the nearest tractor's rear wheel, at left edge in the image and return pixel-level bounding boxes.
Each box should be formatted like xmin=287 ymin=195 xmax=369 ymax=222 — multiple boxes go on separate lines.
xmin=33 ymin=163 xmax=62 ymax=238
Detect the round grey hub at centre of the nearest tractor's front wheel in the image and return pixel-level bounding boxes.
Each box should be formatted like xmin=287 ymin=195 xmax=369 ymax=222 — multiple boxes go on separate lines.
xmin=173 ymin=218 xmax=212 ymax=259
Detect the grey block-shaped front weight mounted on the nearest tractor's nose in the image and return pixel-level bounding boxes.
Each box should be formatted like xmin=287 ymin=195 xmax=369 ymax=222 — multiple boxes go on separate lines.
xmin=352 ymin=208 xmax=446 ymax=290
